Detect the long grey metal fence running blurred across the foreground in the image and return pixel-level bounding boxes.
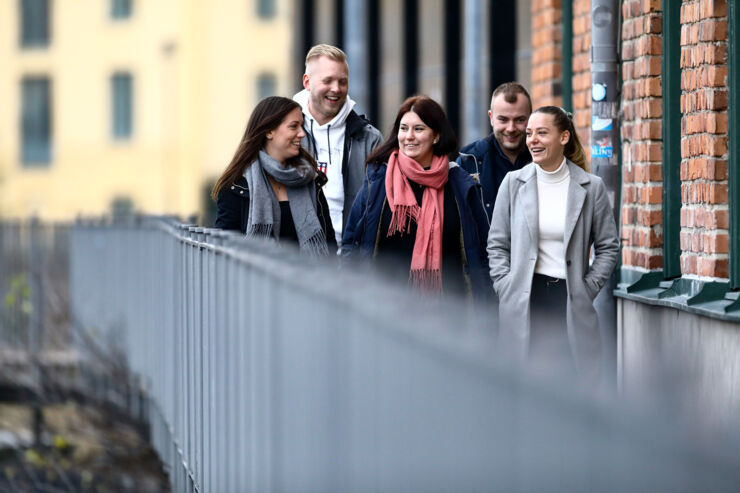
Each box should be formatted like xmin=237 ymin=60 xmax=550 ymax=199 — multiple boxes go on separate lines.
xmin=65 ymin=218 xmax=740 ymax=492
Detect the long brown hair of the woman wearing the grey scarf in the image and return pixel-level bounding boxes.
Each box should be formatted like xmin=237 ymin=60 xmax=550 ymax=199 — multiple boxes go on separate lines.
xmin=211 ymin=96 xmax=317 ymax=200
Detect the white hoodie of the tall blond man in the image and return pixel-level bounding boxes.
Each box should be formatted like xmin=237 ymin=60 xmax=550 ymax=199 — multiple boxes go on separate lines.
xmin=293 ymin=89 xmax=355 ymax=245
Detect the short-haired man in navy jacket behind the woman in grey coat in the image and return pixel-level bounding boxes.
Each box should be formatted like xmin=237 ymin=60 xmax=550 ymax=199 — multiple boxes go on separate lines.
xmin=457 ymin=82 xmax=532 ymax=221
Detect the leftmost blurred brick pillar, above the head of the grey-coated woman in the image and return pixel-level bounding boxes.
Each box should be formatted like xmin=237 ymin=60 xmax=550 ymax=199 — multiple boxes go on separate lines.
xmin=529 ymin=0 xmax=563 ymax=108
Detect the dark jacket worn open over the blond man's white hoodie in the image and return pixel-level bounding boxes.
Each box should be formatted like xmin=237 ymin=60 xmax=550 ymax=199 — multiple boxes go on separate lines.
xmin=302 ymin=110 xmax=383 ymax=234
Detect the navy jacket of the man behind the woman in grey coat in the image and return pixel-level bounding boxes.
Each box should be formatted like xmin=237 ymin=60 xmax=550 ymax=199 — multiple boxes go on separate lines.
xmin=456 ymin=134 xmax=532 ymax=220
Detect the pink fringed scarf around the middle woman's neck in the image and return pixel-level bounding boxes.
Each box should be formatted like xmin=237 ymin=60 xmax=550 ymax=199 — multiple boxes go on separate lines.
xmin=385 ymin=151 xmax=450 ymax=293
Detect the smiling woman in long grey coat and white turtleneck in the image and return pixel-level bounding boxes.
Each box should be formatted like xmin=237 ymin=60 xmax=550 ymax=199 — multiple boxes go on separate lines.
xmin=487 ymin=106 xmax=619 ymax=380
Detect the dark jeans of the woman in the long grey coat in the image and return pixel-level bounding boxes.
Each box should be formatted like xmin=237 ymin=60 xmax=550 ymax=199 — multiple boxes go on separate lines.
xmin=529 ymin=274 xmax=575 ymax=369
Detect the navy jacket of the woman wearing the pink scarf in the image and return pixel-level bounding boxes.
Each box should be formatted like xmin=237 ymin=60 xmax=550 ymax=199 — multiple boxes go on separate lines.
xmin=342 ymin=163 xmax=493 ymax=298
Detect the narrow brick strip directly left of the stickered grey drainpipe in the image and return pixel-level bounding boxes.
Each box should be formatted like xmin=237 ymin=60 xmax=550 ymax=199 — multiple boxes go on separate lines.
xmin=573 ymin=0 xmax=591 ymax=159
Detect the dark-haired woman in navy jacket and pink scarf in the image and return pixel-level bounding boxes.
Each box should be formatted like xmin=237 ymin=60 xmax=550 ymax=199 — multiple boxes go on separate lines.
xmin=342 ymin=96 xmax=490 ymax=296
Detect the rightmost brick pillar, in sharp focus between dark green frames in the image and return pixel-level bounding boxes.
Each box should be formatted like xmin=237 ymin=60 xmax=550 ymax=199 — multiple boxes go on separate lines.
xmin=681 ymin=0 xmax=729 ymax=279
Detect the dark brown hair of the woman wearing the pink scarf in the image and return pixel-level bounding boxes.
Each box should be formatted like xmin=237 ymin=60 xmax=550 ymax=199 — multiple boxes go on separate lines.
xmin=365 ymin=96 xmax=457 ymax=164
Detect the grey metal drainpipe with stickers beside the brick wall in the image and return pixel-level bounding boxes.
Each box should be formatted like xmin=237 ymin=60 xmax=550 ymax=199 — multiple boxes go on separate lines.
xmin=590 ymin=0 xmax=620 ymax=383
